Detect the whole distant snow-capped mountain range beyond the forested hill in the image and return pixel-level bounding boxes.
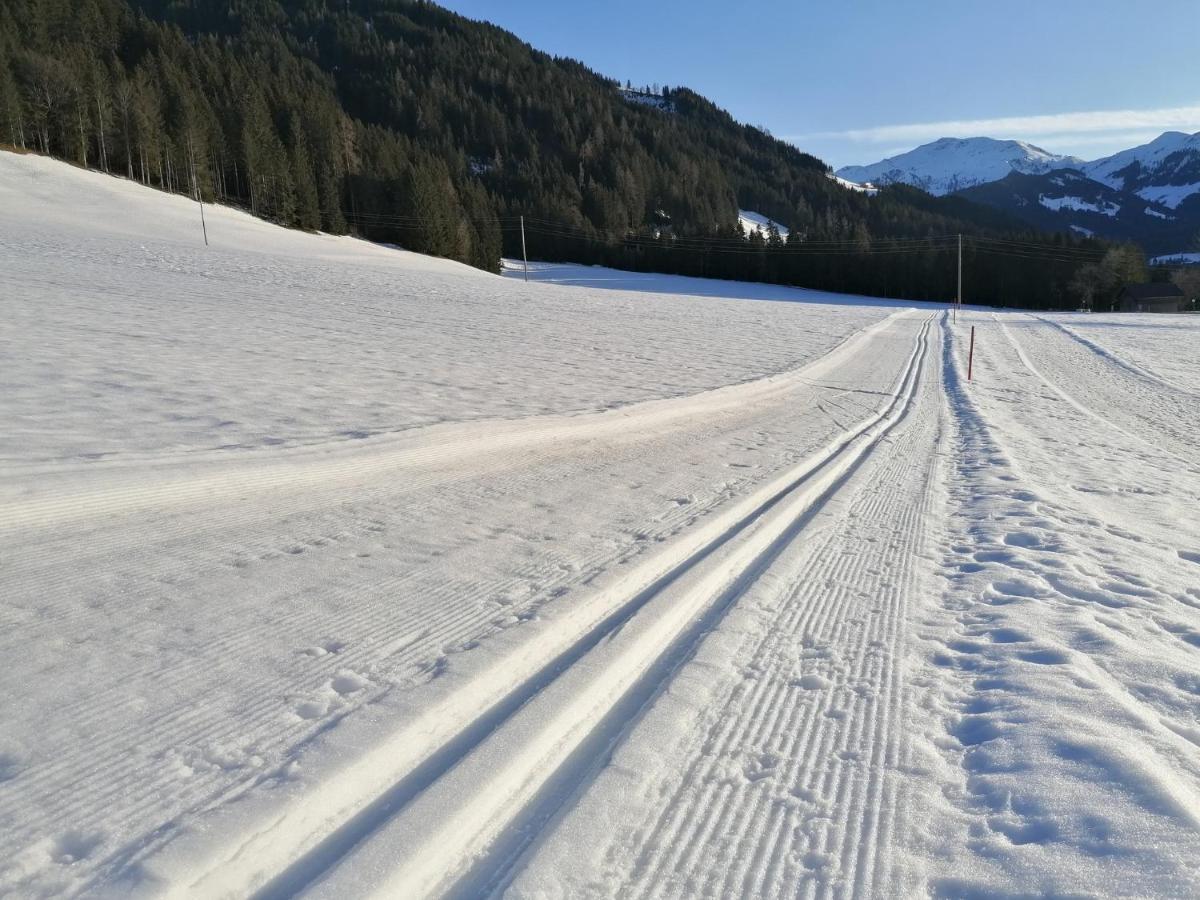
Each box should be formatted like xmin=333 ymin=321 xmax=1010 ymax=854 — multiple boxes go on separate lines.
xmin=838 ymin=131 xmax=1200 ymax=256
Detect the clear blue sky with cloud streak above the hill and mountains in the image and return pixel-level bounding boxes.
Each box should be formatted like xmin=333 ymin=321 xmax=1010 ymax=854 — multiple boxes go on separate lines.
xmin=444 ymin=0 xmax=1200 ymax=166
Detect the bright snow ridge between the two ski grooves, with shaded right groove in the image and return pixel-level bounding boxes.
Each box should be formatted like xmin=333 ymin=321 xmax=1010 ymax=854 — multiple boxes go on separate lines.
xmin=260 ymin=329 xmax=926 ymax=896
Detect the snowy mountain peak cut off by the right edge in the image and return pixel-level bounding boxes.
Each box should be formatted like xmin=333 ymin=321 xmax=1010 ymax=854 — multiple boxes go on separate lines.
xmin=1080 ymin=131 xmax=1200 ymax=209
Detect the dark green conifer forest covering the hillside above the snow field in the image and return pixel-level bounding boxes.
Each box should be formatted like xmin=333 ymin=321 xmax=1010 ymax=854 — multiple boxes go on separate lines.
xmin=0 ymin=0 xmax=1144 ymax=308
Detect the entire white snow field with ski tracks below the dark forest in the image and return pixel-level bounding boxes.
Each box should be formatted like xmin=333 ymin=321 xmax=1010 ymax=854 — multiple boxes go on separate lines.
xmin=0 ymin=154 xmax=1200 ymax=898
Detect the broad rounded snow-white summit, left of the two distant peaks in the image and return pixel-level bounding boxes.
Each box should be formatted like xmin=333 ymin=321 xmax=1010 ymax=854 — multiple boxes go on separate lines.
xmin=836 ymin=138 xmax=1084 ymax=196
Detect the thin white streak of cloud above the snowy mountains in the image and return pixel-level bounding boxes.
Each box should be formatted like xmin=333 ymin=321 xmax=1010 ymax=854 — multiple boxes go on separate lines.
xmin=785 ymin=104 xmax=1200 ymax=144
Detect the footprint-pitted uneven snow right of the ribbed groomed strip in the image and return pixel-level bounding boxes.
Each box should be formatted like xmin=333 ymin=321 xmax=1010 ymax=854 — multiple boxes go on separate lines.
xmin=910 ymin=314 xmax=1200 ymax=896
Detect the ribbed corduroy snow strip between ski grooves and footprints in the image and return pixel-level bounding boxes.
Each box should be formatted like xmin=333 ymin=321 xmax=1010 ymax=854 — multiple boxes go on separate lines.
xmin=501 ymin=319 xmax=940 ymax=896
